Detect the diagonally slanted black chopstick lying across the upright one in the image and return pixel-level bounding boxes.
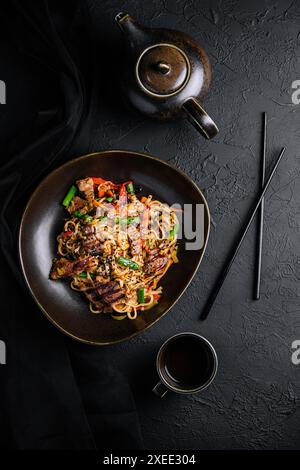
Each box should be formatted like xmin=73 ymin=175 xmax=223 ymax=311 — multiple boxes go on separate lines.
xmin=200 ymin=147 xmax=285 ymax=320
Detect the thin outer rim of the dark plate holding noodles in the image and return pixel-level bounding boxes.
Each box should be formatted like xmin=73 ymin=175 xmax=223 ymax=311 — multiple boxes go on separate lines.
xmin=18 ymin=149 xmax=211 ymax=346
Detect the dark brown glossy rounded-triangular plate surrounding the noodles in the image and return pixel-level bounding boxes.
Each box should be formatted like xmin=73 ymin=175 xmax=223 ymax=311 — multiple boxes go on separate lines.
xmin=19 ymin=150 xmax=210 ymax=345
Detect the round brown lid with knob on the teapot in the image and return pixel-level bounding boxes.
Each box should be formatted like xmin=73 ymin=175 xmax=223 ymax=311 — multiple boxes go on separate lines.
xmin=136 ymin=44 xmax=191 ymax=97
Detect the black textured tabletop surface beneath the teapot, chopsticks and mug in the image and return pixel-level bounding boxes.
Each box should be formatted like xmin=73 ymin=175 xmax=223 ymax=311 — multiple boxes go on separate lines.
xmin=89 ymin=0 xmax=300 ymax=449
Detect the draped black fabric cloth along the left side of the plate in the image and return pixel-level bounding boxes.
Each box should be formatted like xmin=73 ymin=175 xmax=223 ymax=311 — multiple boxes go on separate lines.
xmin=0 ymin=0 xmax=143 ymax=450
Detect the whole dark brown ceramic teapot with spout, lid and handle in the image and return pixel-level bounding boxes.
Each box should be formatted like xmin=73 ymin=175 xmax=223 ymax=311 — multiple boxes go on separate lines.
xmin=115 ymin=12 xmax=219 ymax=139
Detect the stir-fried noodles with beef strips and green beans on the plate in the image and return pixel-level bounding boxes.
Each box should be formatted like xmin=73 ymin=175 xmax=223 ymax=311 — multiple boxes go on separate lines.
xmin=50 ymin=177 xmax=179 ymax=320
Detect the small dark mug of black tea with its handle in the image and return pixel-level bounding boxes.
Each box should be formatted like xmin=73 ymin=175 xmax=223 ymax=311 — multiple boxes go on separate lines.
xmin=154 ymin=333 xmax=218 ymax=396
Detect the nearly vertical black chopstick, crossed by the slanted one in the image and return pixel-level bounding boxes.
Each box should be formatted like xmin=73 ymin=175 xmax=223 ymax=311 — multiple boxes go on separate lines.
xmin=254 ymin=113 xmax=267 ymax=300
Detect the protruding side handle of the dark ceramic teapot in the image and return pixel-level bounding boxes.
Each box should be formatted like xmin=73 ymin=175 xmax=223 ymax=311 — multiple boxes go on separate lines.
xmin=182 ymin=98 xmax=219 ymax=139
